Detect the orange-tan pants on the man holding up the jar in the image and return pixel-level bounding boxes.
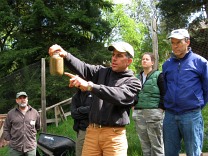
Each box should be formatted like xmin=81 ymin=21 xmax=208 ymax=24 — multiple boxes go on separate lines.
xmin=82 ymin=126 xmax=128 ymax=156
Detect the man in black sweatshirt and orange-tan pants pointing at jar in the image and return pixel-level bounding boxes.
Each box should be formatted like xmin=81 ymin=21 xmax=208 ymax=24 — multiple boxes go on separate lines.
xmin=49 ymin=42 xmax=141 ymax=156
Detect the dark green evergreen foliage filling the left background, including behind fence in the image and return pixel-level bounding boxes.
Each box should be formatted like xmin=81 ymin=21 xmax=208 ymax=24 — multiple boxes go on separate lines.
xmin=0 ymin=0 xmax=112 ymax=113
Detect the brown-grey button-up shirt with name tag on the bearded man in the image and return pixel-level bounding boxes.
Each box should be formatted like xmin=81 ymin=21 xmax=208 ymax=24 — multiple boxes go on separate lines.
xmin=3 ymin=105 xmax=40 ymax=152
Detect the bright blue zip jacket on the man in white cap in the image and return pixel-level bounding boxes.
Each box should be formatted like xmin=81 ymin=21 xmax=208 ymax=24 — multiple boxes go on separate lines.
xmin=163 ymin=51 xmax=208 ymax=114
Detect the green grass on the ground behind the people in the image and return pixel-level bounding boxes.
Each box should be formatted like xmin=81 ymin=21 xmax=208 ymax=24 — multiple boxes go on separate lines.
xmin=0 ymin=106 xmax=208 ymax=156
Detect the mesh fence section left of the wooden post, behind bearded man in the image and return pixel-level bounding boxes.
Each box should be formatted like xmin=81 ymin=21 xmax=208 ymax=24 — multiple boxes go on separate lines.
xmin=0 ymin=62 xmax=40 ymax=114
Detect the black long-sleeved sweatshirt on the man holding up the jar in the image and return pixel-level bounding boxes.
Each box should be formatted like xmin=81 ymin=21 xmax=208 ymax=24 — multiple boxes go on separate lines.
xmin=65 ymin=53 xmax=141 ymax=126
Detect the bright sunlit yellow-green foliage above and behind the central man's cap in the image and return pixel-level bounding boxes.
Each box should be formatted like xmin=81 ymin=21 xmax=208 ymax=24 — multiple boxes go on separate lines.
xmin=106 ymin=2 xmax=148 ymax=72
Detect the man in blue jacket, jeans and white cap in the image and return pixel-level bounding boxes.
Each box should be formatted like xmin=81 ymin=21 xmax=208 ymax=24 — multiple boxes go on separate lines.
xmin=162 ymin=29 xmax=208 ymax=156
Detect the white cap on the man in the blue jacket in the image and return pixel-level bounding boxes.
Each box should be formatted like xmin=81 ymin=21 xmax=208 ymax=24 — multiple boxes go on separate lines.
xmin=168 ymin=29 xmax=190 ymax=40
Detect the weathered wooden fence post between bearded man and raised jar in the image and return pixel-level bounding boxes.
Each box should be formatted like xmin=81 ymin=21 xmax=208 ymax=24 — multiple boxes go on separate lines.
xmin=41 ymin=58 xmax=47 ymax=133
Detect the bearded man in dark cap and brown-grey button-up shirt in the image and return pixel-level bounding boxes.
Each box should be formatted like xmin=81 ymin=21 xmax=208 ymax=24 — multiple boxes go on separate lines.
xmin=3 ymin=92 xmax=40 ymax=156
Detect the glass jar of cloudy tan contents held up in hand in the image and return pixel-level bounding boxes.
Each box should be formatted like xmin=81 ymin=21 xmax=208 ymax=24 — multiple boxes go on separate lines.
xmin=50 ymin=52 xmax=64 ymax=76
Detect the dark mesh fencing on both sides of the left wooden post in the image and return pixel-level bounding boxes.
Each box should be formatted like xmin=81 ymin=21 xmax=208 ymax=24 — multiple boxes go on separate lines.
xmin=0 ymin=60 xmax=76 ymax=114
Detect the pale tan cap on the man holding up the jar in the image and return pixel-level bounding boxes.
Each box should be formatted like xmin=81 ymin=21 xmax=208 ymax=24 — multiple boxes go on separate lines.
xmin=108 ymin=42 xmax=134 ymax=58
